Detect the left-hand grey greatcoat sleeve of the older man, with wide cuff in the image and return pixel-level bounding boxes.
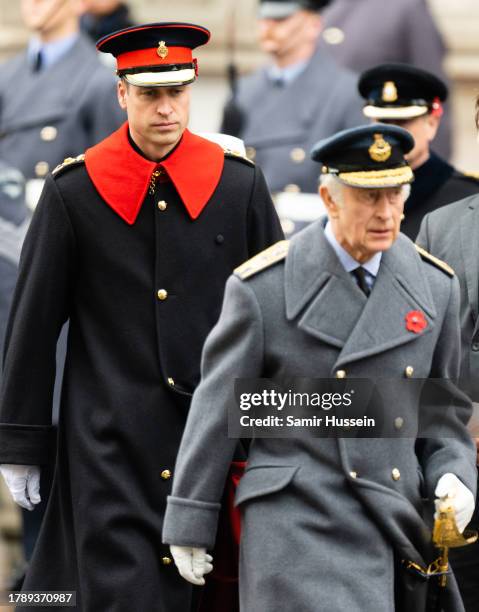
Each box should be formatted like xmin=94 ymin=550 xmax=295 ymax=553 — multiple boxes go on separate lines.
xmin=163 ymin=276 xmax=263 ymax=549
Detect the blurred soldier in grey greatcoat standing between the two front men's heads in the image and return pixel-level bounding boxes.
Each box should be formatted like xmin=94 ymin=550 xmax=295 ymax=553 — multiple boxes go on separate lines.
xmin=221 ymin=0 xmax=364 ymax=193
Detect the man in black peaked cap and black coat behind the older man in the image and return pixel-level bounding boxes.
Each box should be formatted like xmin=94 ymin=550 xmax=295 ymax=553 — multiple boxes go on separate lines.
xmin=358 ymin=64 xmax=479 ymax=240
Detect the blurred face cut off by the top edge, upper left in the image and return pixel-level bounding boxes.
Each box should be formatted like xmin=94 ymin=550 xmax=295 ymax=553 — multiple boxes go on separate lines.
xmin=21 ymin=0 xmax=83 ymax=42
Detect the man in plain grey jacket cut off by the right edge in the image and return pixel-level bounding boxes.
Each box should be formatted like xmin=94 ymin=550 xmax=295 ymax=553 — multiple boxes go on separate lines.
xmin=416 ymin=99 xmax=479 ymax=612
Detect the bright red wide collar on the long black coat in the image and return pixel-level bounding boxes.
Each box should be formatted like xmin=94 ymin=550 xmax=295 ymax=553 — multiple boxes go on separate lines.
xmin=85 ymin=123 xmax=224 ymax=225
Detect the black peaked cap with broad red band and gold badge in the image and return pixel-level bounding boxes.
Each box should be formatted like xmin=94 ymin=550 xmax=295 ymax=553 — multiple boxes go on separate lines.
xmin=96 ymin=23 xmax=210 ymax=87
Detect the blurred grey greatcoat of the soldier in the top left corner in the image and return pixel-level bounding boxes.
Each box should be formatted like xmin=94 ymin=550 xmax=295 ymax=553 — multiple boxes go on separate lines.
xmin=0 ymin=34 xmax=126 ymax=179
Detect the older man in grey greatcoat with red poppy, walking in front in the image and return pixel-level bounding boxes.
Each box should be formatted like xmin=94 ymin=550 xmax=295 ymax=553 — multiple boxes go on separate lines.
xmin=163 ymin=124 xmax=477 ymax=612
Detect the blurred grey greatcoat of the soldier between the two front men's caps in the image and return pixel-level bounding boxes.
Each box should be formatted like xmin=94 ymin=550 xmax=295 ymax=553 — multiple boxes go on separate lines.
xmin=224 ymin=50 xmax=366 ymax=193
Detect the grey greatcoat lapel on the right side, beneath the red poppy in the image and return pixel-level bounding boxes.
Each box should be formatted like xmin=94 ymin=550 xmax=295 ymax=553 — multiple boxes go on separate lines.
xmin=334 ymin=234 xmax=436 ymax=369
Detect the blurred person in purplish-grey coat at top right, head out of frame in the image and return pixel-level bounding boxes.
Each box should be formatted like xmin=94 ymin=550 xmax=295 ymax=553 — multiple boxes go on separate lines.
xmin=320 ymin=0 xmax=452 ymax=159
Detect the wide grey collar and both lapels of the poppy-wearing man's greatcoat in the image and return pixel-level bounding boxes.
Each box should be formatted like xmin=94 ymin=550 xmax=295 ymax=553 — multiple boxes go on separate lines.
xmin=285 ymin=227 xmax=436 ymax=369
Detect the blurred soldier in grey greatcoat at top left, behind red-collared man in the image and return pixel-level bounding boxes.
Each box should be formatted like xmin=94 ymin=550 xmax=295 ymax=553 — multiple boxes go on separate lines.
xmin=0 ymin=0 xmax=126 ymax=180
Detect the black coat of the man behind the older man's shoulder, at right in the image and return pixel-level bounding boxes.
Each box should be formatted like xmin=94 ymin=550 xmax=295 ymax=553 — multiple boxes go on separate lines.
xmin=401 ymin=152 xmax=479 ymax=240
